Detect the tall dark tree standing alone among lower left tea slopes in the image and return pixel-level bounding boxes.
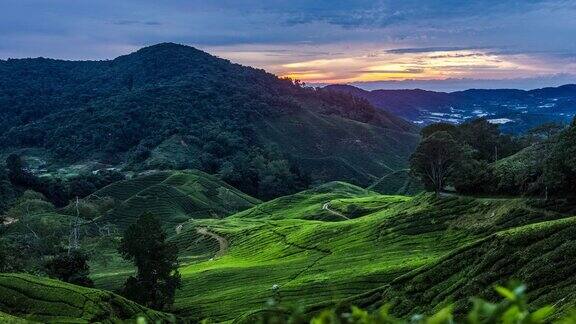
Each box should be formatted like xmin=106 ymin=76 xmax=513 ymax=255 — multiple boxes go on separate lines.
xmin=118 ymin=213 xmax=181 ymax=309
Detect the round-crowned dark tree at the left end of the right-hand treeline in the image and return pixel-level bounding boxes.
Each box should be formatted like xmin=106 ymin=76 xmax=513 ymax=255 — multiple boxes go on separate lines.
xmin=410 ymin=131 xmax=463 ymax=194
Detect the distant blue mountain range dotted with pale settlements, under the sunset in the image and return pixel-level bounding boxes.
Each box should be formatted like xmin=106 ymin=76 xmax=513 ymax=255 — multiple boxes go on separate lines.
xmin=325 ymin=84 xmax=576 ymax=133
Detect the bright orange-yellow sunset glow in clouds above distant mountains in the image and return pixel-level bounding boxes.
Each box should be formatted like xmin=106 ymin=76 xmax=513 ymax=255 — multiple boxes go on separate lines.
xmin=278 ymin=51 xmax=545 ymax=83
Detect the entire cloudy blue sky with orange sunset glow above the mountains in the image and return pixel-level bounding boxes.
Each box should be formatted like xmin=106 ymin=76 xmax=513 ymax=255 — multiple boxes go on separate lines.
xmin=0 ymin=0 xmax=576 ymax=91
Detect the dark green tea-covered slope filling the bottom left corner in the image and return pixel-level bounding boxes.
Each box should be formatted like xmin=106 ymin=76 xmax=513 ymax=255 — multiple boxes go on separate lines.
xmin=0 ymin=274 xmax=173 ymax=323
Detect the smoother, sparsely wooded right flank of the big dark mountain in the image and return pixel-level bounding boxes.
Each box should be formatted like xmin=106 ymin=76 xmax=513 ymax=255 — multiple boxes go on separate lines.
xmin=257 ymin=109 xmax=419 ymax=186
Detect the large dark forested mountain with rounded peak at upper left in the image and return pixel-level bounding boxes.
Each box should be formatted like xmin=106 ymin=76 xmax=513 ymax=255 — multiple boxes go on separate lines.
xmin=0 ymin=43 xmax=418 ymax=196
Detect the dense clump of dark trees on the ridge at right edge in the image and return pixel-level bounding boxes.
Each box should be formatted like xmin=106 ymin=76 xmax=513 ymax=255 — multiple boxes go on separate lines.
xmin=410 ymin=119 xmax=576 ymax=198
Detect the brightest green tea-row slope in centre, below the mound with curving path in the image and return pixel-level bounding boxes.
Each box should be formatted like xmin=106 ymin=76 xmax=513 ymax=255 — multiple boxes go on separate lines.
xmin=164 ymin=196 xmax=555 ymax=320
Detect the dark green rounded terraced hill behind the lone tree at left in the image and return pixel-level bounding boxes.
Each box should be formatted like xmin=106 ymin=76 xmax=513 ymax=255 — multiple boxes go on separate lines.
xmin=89 ymin=170 xmax=260 ymax=228
